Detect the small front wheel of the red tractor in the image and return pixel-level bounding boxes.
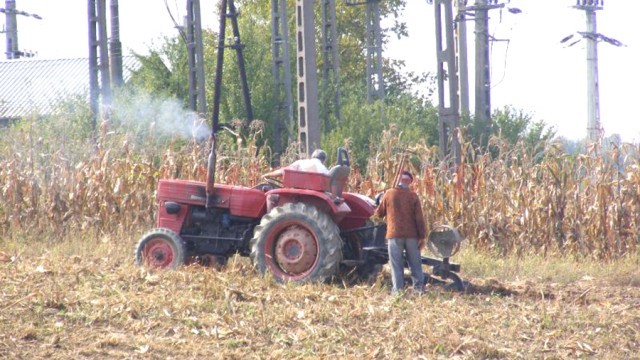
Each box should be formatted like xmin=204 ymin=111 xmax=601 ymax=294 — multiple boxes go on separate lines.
xmin=136 ymin=228 xmax=186 ymax=269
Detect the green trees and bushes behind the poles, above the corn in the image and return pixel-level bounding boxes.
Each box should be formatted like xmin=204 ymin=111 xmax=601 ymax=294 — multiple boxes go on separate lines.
xmin=124 ymin=0 xmax=555 ymax=169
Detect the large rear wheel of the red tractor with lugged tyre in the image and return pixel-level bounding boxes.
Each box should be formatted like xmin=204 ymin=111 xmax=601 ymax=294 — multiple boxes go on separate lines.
xmin=250 ymin=203 xmax=342 ymax=282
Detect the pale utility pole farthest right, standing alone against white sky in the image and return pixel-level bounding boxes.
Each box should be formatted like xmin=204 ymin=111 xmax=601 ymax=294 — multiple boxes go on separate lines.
xmin=575 ymin=0 xmax=604 ymax=142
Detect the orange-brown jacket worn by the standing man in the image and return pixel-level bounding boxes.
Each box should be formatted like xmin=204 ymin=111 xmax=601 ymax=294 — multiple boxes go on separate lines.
xmin=376 ymin=188 xmax=427 ymax=239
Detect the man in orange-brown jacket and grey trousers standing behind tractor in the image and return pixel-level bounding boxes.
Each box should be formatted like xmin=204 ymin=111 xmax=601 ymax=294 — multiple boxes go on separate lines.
xmin=376 ymin=171 xmax=426 ymax=294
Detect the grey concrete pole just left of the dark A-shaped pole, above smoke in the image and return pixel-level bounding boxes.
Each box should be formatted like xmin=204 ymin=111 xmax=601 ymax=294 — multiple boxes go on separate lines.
xmin=185 ymin=0 xmax=207 ymax=114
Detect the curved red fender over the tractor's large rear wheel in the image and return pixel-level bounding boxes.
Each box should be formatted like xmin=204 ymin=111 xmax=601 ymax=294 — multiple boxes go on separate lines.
xmin=266 ymin=188 xmax=351 ymax=224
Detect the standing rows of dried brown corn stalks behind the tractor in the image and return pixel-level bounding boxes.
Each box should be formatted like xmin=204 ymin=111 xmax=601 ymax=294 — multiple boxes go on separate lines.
xmin=0 ymin=121 xmax=640 ymax=259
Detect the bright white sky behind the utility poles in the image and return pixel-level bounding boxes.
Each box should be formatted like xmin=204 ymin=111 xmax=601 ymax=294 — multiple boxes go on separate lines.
xmin=5 ymin=0 xmax=640 ymax=141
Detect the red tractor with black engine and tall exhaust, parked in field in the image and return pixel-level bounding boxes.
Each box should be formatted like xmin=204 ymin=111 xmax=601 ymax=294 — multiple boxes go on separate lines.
xmin=136 ymin=148 xmax=387 ymax=281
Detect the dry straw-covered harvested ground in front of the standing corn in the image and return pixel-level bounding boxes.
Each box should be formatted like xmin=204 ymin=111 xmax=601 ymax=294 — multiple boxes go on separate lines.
xmin=0 ymin=232 xmax=640 ymax=359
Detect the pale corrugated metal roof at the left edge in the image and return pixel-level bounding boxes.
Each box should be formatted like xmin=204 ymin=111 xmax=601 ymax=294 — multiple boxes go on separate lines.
xmin=0 ymin=56 xmax=139 ymax=119
